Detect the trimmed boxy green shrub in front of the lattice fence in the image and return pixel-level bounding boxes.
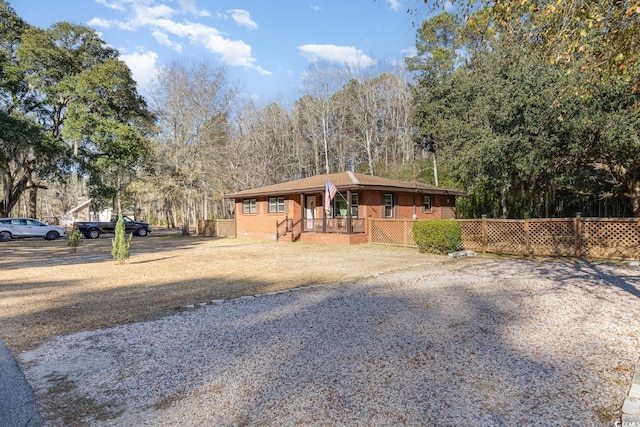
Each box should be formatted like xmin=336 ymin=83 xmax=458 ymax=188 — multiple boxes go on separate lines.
xmin=413 ymin=219 xmax=462 ymax=254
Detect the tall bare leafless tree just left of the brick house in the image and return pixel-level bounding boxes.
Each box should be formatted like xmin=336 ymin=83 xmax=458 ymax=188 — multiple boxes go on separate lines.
xmin=152 ymin=62 xmax=236 ymax=234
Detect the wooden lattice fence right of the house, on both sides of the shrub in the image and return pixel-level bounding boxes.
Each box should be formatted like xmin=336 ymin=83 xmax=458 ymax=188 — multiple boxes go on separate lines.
xmin=369 ymin=217 xmax=640 ymax=259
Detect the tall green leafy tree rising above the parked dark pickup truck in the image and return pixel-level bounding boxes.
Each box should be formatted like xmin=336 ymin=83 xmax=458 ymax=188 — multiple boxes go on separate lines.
xmin=17 ymin=22 xmax=153 ymax=213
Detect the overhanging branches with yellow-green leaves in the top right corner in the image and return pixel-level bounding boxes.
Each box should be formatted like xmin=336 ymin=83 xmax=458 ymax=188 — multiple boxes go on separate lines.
xmin=420 ymin=0 xmax=640 ymax=92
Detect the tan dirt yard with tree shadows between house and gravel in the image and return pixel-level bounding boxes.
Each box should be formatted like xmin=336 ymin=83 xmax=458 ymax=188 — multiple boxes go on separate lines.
xmin=0 ymin=230 xmax=460 ymax=353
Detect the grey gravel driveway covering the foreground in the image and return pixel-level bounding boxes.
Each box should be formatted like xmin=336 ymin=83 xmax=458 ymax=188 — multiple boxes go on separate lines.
xmin=19 ymin=259 xmax=640 ymax=426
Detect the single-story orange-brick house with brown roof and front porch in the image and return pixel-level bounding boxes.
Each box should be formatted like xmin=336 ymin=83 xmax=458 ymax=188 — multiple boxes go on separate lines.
xmin=225 ymin=172 xmax=464 ymax=244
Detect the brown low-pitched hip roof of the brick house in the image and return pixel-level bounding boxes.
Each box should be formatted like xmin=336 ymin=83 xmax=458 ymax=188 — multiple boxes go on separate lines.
xmin=225 ymin=172 xmax=464 ymax=199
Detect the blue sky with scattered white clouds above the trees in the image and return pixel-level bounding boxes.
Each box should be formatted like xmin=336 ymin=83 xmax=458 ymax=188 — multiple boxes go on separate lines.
xmin=8 ymin=0 xmax=422 ymax=103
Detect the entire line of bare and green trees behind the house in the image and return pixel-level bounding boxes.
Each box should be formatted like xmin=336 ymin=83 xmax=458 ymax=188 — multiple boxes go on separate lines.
xmin=0 ymin=1 xmax=640 ymax=227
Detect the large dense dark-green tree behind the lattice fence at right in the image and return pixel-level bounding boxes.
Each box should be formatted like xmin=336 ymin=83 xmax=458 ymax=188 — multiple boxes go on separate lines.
xmin=413 ymin=7 xmax=640 ymax=217
